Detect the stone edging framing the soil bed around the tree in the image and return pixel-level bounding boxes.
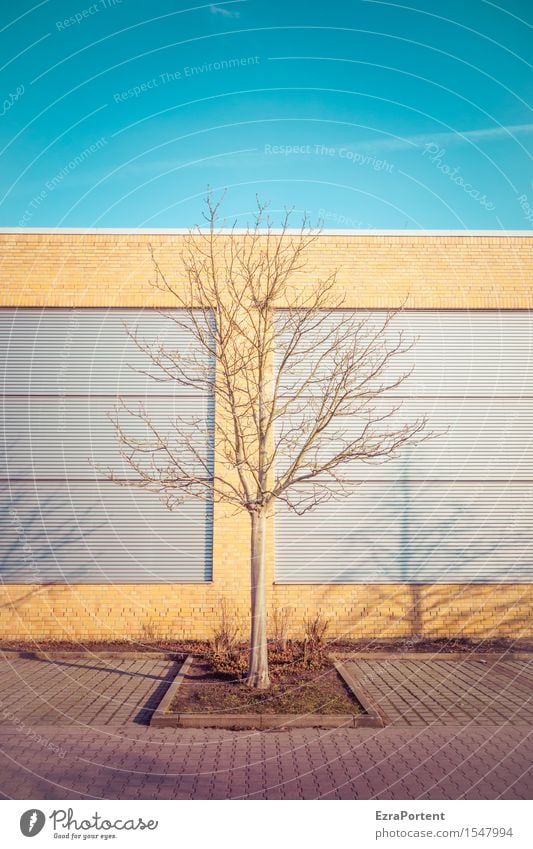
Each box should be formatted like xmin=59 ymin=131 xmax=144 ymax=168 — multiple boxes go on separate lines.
xmin=150 ymin=654 xmax=384 ymax=730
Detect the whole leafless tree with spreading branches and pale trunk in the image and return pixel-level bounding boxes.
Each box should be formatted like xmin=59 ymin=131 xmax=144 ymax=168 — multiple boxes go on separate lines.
xmin=104 ymin=196 xmax=426 ymax=688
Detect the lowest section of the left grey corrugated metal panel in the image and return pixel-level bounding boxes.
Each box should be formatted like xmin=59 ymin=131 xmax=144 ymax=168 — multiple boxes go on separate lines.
xmin=0 ymin=481 xmax=212 ymax=584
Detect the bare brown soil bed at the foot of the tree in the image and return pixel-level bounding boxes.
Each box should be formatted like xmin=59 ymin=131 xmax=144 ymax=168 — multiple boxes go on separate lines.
xmin=170 ymin=658 xmax=364 ymax=714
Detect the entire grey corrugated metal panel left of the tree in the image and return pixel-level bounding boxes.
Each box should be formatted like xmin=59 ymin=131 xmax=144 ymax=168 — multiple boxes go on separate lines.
xmin=0 ymin=309 xmax=214 ymax=583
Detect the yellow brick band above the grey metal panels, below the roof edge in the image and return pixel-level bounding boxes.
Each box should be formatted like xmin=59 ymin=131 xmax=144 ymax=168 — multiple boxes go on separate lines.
xmin=0 ymin=233 xmax=533 ymax=309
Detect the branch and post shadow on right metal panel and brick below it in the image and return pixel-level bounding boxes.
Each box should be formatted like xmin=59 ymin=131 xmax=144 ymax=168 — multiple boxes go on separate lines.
xmin=308 ymin=460 xmax=533 ymax=639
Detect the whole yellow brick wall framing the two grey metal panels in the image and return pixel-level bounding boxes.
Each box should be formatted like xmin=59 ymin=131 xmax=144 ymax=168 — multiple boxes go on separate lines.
xmin=0 ymin=232 xmax=533 ymax=639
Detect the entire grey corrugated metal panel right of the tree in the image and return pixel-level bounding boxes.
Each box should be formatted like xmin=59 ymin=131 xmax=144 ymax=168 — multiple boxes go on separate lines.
xmin=275 ymin=311 xmax=533 ymax=584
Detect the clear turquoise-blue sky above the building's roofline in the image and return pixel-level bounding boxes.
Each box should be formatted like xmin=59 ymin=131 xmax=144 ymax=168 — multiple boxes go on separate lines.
xmin=0 ymin=0 xmax=533 ymax=230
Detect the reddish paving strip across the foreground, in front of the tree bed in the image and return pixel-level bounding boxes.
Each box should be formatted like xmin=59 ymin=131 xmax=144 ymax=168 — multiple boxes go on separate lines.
xmin=0 ymin=724 xmax=533 ymax=799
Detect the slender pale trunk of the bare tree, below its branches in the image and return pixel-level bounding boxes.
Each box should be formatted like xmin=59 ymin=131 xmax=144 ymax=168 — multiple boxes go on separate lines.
xmin=246 ymin=512 xmax=270 ymax=690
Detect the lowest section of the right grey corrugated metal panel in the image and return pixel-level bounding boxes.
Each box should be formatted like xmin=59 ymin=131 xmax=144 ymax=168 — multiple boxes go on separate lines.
xmin=276 ymin=481 xmax=533 ymax=584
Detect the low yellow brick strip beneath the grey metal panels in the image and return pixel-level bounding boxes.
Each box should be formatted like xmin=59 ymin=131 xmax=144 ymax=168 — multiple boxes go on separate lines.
xmin=0 ymin=580 xmax=533 ymax=641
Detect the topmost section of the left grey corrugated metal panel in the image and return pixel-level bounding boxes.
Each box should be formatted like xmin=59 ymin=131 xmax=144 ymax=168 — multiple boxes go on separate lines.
xmin=0 ymin=308 xmax=212 ymax=396
